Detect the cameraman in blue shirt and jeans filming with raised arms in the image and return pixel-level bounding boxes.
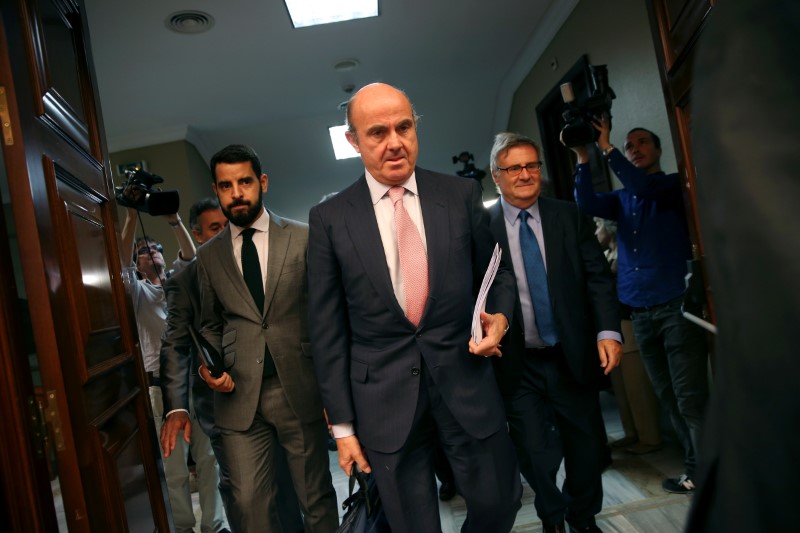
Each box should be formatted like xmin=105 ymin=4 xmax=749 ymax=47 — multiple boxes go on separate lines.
xmin=572 ymin=120 xmax=708 ymax=493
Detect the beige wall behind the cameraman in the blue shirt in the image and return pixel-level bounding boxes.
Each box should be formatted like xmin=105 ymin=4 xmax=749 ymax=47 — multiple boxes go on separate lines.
xmin=508 ymin=0 xmax=677 ymax=187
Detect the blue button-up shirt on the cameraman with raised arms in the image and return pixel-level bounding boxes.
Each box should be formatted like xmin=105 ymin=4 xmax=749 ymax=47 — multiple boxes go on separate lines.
xmin=575 ymin=149 xmax=692 ymax=307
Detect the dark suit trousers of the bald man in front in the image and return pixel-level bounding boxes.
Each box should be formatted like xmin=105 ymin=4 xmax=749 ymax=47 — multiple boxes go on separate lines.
xmin=367 ymin=366 xmax=522 ymax=533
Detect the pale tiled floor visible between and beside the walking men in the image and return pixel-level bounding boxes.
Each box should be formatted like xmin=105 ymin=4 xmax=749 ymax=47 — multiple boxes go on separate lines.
xmin=193 ymin=392 xmax=691 ymax=533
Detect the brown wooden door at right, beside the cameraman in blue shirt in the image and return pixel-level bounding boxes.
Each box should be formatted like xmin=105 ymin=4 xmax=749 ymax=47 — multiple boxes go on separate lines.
xmin=647 ymin=0 xmax=716 ymax=322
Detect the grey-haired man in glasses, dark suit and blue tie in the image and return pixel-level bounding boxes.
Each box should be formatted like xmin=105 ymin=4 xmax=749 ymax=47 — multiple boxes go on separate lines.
xmin=489 ymin=133 xmax=622 ymax=531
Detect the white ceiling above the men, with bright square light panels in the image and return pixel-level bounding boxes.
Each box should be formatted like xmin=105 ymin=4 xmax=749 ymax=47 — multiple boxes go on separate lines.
xmin=85 ymin=0 xmax=578 ymax=220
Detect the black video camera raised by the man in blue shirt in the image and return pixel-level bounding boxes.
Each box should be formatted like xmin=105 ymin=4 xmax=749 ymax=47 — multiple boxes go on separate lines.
xmin=561 ymin=65 xmax=617 ymax=148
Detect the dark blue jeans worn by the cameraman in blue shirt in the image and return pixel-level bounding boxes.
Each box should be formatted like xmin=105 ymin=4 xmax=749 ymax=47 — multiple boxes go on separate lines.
xmin=631 ymin=298 xmax=708 ymax=479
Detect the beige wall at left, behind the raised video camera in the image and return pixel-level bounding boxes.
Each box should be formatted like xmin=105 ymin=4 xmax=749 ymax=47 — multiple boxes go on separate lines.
xmin=109 ymin=137 xmax=214 ymax=265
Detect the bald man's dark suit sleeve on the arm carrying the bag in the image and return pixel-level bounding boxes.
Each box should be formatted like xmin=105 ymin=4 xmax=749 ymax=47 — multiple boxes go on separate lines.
xmin=308 ymin=206 xmax=355 ymax=424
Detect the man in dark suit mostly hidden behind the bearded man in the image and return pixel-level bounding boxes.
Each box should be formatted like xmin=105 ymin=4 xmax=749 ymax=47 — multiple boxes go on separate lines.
xmin=161 ymin=198 xmax=303 ymax=533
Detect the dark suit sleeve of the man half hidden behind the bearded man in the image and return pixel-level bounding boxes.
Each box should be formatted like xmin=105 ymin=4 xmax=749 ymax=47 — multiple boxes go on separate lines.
xmin=161 ymin=271 xmax=194 ymax=413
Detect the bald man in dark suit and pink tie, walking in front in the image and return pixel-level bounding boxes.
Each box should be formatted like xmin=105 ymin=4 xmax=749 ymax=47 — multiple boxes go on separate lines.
xmin=308 ymin=84 xmax=521 ymax=532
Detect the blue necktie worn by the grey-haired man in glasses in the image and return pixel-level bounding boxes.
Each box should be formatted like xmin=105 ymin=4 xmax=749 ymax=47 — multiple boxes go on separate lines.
xmin=519 ymin=209 xmax=558 ymax=346
